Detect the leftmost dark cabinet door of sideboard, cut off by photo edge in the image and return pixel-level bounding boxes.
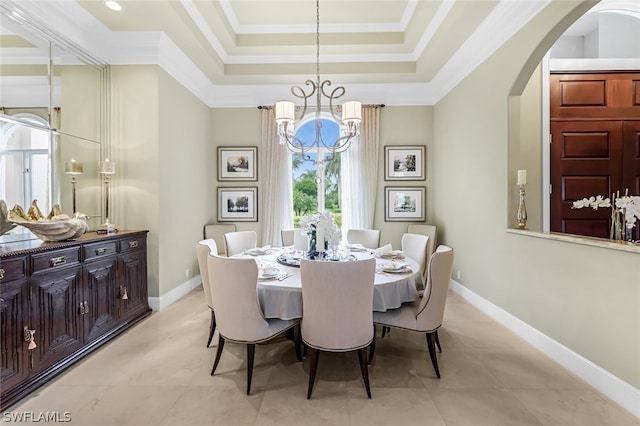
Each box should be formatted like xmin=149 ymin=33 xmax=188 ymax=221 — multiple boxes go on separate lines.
xmin=0 ymin=279 xmax=29 ymax=392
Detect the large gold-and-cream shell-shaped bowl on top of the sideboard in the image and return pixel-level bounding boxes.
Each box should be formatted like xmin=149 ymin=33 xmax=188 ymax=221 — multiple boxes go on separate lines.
xmin=8 ymin=200 xmax=89 ymax=241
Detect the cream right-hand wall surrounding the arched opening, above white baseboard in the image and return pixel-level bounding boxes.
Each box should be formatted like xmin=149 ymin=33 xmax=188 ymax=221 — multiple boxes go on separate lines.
xmin=433 ymin=1 xmax=640 ymax=388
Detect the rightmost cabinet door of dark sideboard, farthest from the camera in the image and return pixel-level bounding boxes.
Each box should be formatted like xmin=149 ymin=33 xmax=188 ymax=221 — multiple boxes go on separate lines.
xmin=119 ymin=250 xmax=149 ymax=317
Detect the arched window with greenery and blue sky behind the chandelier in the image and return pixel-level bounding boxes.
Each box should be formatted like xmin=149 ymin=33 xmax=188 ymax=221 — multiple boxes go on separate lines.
xmin=291 ymin=113 xmax=341 ymax=227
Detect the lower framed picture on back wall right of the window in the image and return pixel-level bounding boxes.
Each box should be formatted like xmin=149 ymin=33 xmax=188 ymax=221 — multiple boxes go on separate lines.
xmin=384 ymin=186 xmax=427 ymax=222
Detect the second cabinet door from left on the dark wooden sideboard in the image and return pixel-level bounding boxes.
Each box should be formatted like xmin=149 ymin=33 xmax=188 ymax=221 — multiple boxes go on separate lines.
xmin=30 ymin=267 xmax=83 ymax=372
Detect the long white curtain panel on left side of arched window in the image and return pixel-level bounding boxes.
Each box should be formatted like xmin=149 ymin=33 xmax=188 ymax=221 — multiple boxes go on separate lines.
xmin=258 ymin=108 xmax=293 ymax=246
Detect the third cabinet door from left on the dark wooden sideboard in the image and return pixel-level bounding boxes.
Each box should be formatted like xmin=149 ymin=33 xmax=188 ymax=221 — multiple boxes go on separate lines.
xmin=84 ymin=256 xmax=118 ymax=341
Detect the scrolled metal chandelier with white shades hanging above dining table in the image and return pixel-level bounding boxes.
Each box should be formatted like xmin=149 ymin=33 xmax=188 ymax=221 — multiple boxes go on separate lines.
xmin=275 ymin=0 xmax=362 ymax=162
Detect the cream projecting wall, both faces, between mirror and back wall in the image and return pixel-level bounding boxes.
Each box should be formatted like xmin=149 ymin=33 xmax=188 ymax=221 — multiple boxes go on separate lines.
xmin=111 ymin=65 xmax=213 ymax=297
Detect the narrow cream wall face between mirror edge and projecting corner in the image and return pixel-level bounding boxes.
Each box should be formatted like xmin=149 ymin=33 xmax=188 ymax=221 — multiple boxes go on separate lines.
xmin=110 ymin=65 xmax=164 ymax=297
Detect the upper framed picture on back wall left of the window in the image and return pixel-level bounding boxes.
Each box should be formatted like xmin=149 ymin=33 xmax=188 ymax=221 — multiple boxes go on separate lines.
xmin=218 ymin=146 xmax=258 ymax=181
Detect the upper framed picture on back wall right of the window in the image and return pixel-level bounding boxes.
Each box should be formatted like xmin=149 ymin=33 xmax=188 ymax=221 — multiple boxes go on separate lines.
xmin=384 ymin=145 xmax=427 ymax=180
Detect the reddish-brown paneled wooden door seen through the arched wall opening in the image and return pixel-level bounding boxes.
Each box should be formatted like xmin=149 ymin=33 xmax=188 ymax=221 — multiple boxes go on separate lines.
xmin=550 ymin=72 xmax=640 ymax=239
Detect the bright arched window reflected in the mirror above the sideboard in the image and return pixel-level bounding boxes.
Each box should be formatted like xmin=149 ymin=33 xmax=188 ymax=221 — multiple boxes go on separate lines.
xmin=0 ymin=113 xmax=51 ymax=214
